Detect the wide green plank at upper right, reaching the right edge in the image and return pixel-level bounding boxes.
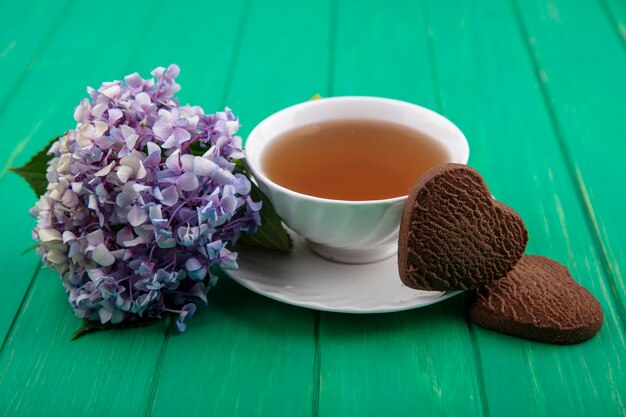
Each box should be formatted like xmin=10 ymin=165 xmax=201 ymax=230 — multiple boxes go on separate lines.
xmin=519 ymin=1 xmax=626 ymax=328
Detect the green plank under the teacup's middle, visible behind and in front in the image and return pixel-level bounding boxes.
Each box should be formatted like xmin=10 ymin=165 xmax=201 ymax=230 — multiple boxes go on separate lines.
xmin=319 ymin=1 xmax=482 ymax=416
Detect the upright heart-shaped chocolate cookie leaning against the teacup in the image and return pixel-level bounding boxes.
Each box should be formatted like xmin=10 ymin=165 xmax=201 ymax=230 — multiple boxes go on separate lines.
xmin=398 ymin=164 xmax=528 ymax=291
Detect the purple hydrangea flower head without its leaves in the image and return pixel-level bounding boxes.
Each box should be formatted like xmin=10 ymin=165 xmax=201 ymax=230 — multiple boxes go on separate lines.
xmin=31 ymin=65 xmax=261 ymax=331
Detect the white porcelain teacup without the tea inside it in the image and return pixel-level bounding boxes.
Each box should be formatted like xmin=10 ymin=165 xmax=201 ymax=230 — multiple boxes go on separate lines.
xmin=245 ymin=97 xmax=469 ymax=263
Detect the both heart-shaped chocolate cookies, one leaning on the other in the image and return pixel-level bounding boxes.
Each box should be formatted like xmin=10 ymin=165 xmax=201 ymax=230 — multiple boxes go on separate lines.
xmin=398 ymin=164 xmax=604 ymax=344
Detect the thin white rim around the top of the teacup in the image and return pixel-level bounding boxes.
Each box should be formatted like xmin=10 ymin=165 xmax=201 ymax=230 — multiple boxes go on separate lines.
xmin=243 ymin=96 xmax=470 ymax=206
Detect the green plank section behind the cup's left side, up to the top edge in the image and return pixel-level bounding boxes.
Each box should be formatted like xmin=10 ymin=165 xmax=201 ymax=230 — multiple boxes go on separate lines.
xmin=227 ymin=0 xmax=330 ymax=138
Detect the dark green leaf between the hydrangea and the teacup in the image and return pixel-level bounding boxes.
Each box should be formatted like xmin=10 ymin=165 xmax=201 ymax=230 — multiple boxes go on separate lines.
xmin=234 ymin=161 xmax=293 ymax=253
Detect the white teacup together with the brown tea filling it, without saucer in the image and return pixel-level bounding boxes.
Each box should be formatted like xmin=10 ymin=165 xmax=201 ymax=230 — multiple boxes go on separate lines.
xmin=245 ymin=97 xmax=469 ymax=263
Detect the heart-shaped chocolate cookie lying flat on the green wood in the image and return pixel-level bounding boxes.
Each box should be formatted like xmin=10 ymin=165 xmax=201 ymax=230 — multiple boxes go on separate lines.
xmin=468 ymin=255 xmax=604 ymax=345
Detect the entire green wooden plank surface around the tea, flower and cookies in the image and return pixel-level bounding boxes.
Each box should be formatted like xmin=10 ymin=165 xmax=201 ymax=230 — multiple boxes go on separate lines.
xmin=0 ymin=0 xmax=626 ymax=417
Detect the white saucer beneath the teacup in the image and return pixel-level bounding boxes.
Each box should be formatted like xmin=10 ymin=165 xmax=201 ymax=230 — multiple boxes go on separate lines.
xmin=225 ymin=229 xmax=460 ymax=313
